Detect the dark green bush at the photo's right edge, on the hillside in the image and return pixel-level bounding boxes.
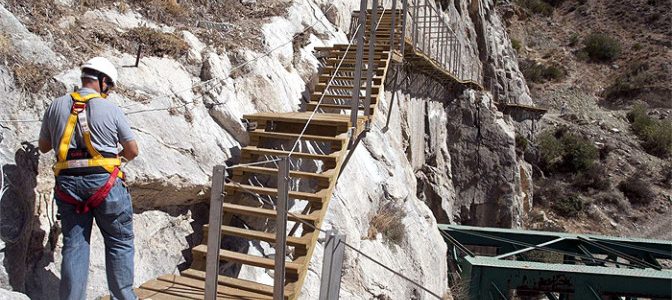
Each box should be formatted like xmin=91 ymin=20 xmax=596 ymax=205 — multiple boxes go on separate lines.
xmin=628 ymin=103 xmax=672 ymax=158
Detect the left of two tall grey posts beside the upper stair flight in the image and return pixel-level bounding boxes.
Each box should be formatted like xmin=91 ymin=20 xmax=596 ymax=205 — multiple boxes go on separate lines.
xmin=348 ymin=0 xmax=367 ymax=149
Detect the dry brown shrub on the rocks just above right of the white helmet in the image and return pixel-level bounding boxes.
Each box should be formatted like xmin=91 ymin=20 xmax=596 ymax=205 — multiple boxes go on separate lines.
xmin=123 ymin=27 xmax=189 ymax=56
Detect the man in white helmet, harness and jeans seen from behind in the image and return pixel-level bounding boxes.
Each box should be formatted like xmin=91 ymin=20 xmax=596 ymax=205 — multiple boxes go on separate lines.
xmin=39 ymin=57 xmax=138 ymax=300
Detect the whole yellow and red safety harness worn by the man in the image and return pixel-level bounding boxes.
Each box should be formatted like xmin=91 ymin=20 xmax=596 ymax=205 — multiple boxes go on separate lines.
xmin=54 ymin=92 xmax=124 ymax=214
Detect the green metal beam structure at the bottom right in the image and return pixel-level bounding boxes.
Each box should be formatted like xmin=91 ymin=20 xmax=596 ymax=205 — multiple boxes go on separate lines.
xmin=439 ymin=224 xmax=672 ymax=300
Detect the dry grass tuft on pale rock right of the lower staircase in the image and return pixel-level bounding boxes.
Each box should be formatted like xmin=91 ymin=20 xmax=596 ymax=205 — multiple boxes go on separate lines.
xmin=368 ymin=203 xmax=406 ymax=244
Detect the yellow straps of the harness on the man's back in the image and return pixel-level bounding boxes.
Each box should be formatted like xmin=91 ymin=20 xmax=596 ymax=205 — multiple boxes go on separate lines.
xmin=54 ymin=92 xmax=124 ymax=178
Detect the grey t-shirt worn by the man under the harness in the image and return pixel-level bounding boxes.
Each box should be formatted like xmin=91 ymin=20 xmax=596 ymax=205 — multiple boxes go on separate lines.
xmin=40 ymin=88 xmax=135 ymax=154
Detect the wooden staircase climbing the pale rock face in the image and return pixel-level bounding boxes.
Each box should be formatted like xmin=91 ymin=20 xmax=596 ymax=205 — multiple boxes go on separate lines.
xmin=129 ymin=8 xmax=401 ymax=299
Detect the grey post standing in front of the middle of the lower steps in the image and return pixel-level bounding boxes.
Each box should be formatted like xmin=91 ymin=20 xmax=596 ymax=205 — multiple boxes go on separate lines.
xmin=273 ymin=157 xmax=289 ymax=300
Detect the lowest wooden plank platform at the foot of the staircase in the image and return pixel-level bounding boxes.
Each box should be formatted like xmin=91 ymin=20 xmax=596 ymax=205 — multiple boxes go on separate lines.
xmin=140 ymin=275 xmax=273 ymax=300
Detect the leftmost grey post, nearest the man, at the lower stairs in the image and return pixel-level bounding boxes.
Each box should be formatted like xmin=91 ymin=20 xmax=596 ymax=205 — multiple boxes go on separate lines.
xmin=205 ymin=165 xmax=226 ymax=300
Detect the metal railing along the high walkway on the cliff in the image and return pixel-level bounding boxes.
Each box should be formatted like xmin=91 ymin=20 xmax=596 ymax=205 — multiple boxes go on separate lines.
xmin=349 ymin=0 xmax=483 ymax=86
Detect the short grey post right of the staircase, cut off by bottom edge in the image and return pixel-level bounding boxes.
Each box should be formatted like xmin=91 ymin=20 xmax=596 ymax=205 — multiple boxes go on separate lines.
xmin=319 ymin=230 xmax=345 ymax=300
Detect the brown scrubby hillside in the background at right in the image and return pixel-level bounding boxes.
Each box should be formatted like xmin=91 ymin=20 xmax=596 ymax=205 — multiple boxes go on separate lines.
xmin=498 ymin=0 xmax=672 ymax=239
